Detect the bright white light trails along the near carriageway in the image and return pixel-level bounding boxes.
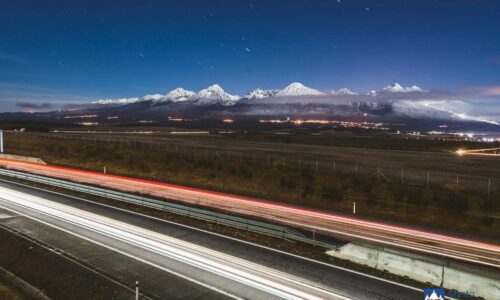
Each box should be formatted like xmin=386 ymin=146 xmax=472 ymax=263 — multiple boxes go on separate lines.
xmin=0 ymin=187 xmax=350 ymax=299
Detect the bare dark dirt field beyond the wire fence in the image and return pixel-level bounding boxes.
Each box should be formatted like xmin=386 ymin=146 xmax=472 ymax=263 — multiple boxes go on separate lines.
xmin=15 ymin=133 xmax=500 ymax=192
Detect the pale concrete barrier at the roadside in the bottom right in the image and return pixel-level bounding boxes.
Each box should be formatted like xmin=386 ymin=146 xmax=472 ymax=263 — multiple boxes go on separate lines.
xmin=326 ymin=243 xmax=500 ymax=299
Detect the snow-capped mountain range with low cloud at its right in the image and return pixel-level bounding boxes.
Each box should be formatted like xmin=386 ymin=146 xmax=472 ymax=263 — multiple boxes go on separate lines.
xmin=0 ymin=82 xmax=499 ymax=131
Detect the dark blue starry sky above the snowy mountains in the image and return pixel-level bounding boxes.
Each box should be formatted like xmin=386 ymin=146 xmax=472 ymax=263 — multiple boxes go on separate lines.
xmin=0 ymin=0 xmax=500 ymax=110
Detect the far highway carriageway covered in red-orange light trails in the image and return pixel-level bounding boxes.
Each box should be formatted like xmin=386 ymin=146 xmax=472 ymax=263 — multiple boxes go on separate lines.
xmin=0 ymin=159 xmax=500 ymax=268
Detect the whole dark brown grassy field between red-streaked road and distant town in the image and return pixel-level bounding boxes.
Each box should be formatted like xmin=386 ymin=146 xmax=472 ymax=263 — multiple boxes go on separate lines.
xmin=6 ymin=135 xmax=500 ymax=238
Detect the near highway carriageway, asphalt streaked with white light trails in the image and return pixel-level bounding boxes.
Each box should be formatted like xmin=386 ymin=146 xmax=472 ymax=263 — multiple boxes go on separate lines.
xmin=0 ymin=181 xmax=422 ymax=299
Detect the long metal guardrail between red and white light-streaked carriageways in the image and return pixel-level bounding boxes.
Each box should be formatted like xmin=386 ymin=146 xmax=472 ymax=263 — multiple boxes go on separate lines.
xmin=0 ymin=168 xmax=339 ymax=249
